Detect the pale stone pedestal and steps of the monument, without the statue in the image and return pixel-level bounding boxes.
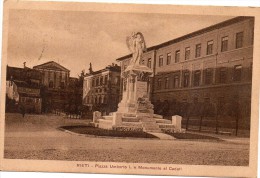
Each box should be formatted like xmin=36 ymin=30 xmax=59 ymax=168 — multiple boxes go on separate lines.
xmin=93 ymin=65 xmax=184 ymax=132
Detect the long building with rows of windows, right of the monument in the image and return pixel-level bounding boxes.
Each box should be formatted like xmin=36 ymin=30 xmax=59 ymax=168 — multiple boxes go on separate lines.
xmin=117 ymin=17 xmax=254 ymax=131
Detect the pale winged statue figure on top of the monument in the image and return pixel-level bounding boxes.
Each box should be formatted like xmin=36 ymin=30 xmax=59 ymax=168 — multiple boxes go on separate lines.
xmin=126 ymin=32 xmax=146 ymax=66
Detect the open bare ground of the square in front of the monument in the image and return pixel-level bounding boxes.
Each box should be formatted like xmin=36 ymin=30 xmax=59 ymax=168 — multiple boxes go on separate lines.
xmin=4 ymin=114 xmax=249 ymax=166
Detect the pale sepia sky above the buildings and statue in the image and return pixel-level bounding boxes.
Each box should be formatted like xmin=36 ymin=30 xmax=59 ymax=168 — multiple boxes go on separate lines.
xmin=7 ymin=10 xmax=232 ymax=77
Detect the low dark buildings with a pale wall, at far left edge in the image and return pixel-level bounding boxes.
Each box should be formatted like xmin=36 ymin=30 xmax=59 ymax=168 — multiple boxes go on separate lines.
xmin=6 ymin=66 xmax=42 ymax=113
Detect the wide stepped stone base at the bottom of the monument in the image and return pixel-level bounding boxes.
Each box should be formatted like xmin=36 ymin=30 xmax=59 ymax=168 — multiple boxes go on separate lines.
xmin=92 ymin=111 xmax=184 ymax=133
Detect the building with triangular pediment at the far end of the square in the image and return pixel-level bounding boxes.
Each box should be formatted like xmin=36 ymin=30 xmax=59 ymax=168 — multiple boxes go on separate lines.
xmin=33 ymin=61 xmax=82 ymax=113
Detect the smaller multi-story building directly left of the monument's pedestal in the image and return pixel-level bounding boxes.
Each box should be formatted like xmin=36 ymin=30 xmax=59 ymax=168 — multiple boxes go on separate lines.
xmin=83 ymin=64 xmax=121 ymax=114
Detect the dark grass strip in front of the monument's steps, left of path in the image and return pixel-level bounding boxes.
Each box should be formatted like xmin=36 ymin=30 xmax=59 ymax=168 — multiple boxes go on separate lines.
xmin=60 ymin=125 xmax=158 ymax=138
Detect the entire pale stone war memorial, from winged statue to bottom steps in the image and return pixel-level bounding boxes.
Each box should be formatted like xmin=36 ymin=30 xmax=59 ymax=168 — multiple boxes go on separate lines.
xmin=92 ymin=32 xmax=182 ymax=132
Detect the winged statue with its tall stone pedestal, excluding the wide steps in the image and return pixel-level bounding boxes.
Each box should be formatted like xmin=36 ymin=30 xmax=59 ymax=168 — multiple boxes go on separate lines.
xmin=118 ymin=32 xmax=153 ymax=113
